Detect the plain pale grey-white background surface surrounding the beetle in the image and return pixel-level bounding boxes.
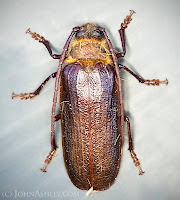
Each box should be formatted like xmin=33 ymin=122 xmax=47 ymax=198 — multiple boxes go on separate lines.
xmin=0 ymin=0 xmax=180 ymax=200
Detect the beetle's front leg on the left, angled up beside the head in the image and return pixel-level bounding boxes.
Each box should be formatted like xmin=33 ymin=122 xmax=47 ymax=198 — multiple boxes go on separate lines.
xmin=26 ymin=28 xmax=61 ymax=59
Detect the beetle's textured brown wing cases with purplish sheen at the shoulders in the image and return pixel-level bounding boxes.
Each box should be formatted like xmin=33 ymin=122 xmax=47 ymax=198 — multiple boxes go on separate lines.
xmin=61 ymin=63 xmax=121 ymax=190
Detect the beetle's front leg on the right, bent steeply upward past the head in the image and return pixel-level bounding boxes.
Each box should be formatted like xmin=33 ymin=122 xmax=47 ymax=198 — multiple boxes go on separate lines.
xmin=116 ymin=10 xmax=135 ymax=58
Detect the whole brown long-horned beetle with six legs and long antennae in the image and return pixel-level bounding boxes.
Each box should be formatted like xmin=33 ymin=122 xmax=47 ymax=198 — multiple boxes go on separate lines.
xmin=12 ymin=10 xmax=168 ymax=191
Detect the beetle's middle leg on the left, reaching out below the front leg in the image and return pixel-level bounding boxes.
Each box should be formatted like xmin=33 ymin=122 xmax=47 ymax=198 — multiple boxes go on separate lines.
xmin=12 ymin=72 xmax=57 ymax=100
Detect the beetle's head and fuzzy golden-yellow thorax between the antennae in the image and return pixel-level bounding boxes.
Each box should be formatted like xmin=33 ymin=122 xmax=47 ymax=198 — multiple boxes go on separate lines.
xmin=66 ymin=24 xmax=113 ymax=67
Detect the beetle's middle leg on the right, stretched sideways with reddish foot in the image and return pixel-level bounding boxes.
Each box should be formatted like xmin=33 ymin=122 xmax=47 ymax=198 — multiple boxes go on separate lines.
xmin=119 ymin=64 xmax=168 ymax=86
